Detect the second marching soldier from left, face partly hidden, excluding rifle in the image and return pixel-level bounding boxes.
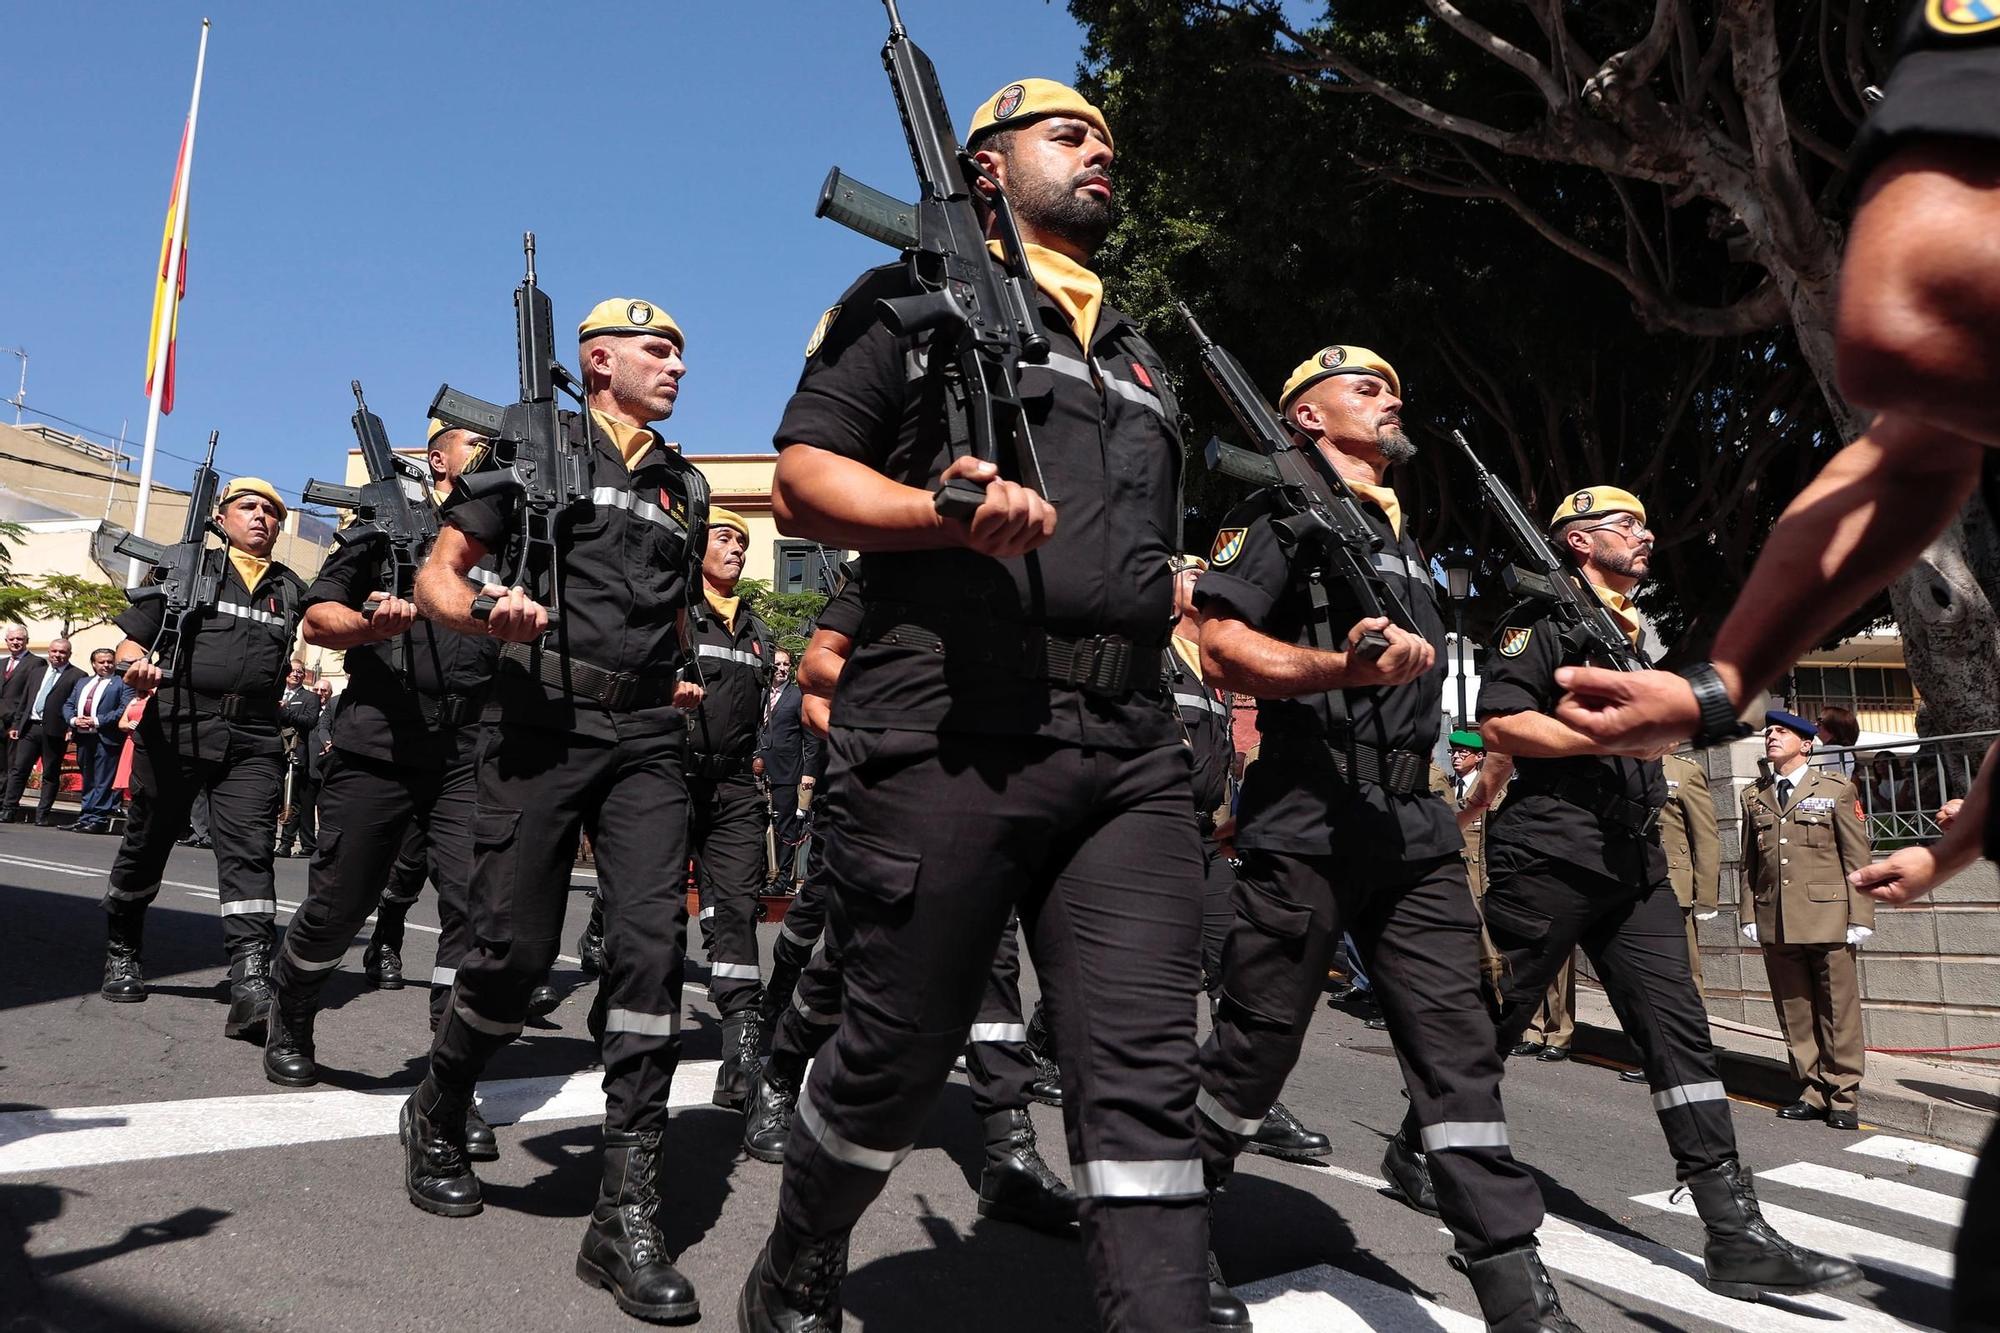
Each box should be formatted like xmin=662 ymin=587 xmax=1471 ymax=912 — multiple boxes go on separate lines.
xmin=264 ymin=420 xmax=500 ymax=1161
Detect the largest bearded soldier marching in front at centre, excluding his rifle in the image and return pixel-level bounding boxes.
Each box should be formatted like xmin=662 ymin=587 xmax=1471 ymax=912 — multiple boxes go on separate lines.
xmin=738 ymin=80 xmax=1206 ymax=1333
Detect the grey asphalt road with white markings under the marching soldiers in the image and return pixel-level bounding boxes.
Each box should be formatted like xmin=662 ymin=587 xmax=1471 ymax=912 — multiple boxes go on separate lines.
xmin=0 ymin=827 xmax=1970 ymax=1333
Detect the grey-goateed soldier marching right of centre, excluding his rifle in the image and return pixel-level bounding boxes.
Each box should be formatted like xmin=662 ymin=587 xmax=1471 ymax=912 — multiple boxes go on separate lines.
xmin=1194 ymin=346 xmax=1576 ymax=1331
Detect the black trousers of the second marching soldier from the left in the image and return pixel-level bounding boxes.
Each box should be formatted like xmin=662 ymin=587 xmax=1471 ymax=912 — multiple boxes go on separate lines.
xmin=272 ymin=727 xmax=478 ymax=1019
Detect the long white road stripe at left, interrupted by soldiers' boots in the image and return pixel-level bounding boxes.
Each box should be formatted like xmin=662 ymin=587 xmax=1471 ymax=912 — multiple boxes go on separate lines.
xmin=0 ymin=1061 xmax=720 ymax=1175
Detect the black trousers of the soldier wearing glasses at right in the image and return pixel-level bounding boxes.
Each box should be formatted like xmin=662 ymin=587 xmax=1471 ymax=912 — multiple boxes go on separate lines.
xmin=1484 ymin=867 xmax=1736 ymax=1179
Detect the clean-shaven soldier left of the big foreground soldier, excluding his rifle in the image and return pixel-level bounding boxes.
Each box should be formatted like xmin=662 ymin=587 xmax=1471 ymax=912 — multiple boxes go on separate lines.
xmin=402 ymin=300 xmax=708 ymax=1319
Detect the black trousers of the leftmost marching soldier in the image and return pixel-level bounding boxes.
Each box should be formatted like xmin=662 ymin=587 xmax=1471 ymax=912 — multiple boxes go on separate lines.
xmin=104 ymin=713 xmax=284 ymax=955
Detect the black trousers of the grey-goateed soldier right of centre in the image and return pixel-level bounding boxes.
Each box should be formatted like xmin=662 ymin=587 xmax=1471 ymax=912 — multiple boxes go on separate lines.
xmin=1200 ymin=851 xmax=1542 ymax=1259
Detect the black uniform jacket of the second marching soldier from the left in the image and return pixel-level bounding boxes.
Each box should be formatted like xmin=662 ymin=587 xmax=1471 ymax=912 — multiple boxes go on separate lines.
xmin=306 ymin=534 xmax=500 ymax=769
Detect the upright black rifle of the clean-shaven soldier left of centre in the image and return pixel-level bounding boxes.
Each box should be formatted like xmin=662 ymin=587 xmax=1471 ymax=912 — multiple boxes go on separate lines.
xmin=430 ymin=232 xmax=590 ymax=628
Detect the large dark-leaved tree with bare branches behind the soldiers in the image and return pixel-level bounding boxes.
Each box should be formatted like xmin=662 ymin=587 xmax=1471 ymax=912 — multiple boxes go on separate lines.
xmin=1070 ymin=0 xmax=2000 ymax=731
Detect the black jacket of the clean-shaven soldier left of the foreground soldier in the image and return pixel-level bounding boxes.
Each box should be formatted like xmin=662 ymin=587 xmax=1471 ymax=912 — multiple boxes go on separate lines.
xmin=440 ymin=412 xmax=706 ymax=741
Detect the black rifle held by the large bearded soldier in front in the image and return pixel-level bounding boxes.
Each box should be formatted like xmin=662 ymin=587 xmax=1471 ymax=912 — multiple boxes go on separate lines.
xmin=814 ymin=0 xmax=1056 ymax=518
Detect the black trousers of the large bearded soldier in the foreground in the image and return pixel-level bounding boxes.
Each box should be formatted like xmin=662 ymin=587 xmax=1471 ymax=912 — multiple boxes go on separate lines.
xmin=778 ymin=727 xmax=1208 ymax=1333
